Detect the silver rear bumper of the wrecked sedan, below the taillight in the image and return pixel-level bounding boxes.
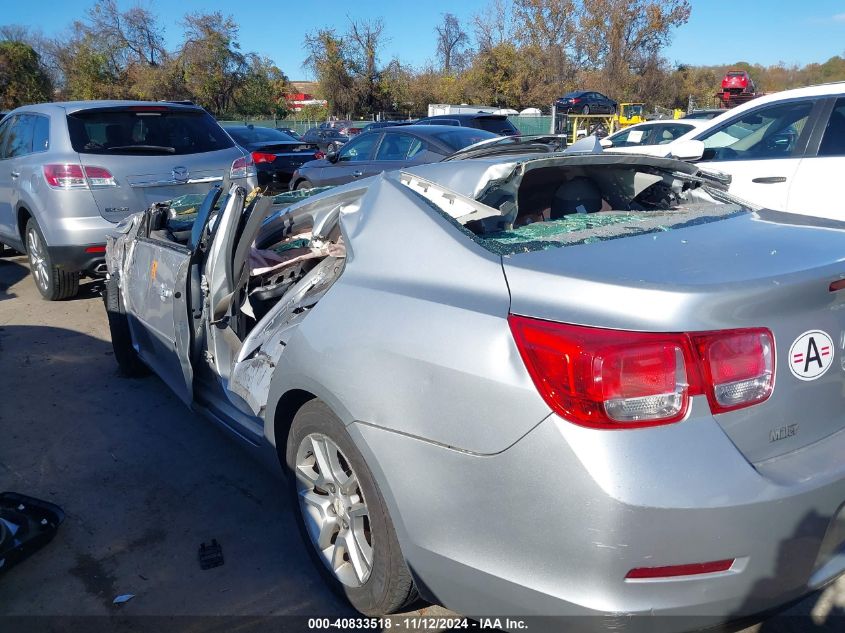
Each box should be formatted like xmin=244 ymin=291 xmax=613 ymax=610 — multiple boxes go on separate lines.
xmin=351 ymin=404 xmax=845 ymax=631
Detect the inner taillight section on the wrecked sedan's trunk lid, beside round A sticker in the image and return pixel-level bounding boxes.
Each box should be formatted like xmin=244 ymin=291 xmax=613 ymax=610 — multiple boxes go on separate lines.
xmin=692 ymin=329 xmax=775 ymax=413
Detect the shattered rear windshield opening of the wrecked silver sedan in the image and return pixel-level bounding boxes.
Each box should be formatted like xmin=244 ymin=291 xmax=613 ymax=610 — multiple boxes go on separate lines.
xmin=403 ymin=154 xmax=752 ymax=256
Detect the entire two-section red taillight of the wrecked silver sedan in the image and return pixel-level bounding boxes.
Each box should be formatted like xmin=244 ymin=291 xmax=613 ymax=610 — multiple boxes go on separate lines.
xmin=508 ymin=315 xmax=774 ymax=429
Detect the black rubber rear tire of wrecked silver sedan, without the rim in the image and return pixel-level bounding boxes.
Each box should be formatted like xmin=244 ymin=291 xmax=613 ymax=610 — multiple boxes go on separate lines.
xmin=285 ymin=400 xmax=419 ymax=616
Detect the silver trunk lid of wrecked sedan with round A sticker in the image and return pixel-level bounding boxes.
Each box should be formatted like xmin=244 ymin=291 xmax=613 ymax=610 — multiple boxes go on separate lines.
xmin=503 ymin=211 xmax=845 ymax=462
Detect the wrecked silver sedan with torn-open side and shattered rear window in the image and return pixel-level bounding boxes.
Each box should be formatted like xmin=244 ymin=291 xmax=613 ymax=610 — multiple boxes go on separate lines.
xmin=105 ymin=150 xmax=845 ymax=630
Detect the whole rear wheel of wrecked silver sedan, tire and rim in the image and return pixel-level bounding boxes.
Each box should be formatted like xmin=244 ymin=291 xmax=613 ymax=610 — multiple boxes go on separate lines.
xmin=285 ymin=400 xmax=418 ymax=616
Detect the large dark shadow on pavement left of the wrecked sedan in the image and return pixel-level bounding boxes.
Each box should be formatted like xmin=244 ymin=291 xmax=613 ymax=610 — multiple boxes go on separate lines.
xmin=0 ymin=324 xmax=355 ymax=630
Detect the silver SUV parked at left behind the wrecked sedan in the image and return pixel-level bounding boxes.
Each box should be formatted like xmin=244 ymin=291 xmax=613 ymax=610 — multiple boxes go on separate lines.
xmin=0 ymin=101 xmax=257 ymax=300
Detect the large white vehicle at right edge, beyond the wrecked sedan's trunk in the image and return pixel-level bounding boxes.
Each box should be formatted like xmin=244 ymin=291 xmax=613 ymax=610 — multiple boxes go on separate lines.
xmin=660 ymin=82 xmax=845 ymax=220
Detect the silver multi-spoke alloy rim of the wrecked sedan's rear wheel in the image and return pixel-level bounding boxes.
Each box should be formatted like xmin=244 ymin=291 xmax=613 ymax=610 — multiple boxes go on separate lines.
xmin=296 ymin=433 xmax=373 ymax=587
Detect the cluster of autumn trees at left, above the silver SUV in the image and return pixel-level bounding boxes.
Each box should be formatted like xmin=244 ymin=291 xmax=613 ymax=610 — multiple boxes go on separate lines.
xmin=0 ymin=0 xmax=288 ymax=116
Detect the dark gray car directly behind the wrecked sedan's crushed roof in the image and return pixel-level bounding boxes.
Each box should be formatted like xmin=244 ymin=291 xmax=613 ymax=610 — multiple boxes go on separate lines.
xmin=290 ymin=125 xmax=498 ymax=189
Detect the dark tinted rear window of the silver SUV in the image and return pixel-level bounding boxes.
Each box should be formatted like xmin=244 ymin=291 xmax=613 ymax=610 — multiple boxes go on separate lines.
xmin=67 ymin=106 xmax=234 ymax=155
